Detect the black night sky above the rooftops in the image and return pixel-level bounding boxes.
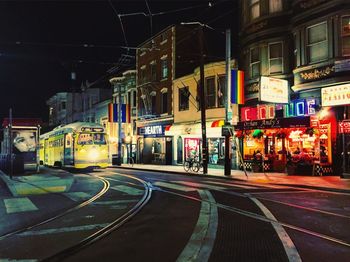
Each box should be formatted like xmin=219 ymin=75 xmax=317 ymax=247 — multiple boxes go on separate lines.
xmin=0 ymin=0 xmax=237 ymax=121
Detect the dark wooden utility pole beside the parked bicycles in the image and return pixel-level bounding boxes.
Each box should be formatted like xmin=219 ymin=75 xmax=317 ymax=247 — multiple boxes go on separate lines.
xmin=198 ymin=25 xmax=208 ymax=175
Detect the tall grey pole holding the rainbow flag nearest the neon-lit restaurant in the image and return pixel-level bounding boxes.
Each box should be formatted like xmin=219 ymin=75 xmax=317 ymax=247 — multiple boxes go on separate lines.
xmin=224 ymin=29 xmax=232 ymax=176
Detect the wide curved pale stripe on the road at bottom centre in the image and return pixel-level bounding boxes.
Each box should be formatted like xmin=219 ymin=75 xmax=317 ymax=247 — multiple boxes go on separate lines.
xmin=176 ymin=190 xmax=218 ymax=262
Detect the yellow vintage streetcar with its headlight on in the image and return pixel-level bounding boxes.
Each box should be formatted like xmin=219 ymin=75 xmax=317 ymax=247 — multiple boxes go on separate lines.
xmin=39 ymin=122 xmax=109 ymax=168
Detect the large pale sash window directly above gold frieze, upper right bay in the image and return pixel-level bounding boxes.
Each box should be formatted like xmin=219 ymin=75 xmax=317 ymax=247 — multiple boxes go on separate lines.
xmin=307 ymin=22 xmax=328 ymax=63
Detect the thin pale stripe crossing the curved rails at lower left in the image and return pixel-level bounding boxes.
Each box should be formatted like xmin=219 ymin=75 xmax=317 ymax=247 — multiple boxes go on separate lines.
xmin=18 ymin=223 xmax=109 ymax=236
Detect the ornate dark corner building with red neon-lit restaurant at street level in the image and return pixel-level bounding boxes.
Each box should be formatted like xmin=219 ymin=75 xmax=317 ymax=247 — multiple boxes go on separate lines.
xmin=236 ymin=0 xmax=350 ymax=176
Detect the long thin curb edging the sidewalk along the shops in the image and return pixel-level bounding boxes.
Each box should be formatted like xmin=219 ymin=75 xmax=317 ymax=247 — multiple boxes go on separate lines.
xmin=110 ymin=166 xmax=350 ymax=193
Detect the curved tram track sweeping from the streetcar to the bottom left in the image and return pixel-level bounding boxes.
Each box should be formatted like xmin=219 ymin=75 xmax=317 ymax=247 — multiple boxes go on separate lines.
xmin=0 ymin=173 xmax=152 ymax=261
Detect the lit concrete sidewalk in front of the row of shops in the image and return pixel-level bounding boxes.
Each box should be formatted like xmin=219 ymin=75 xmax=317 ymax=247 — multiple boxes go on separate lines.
xmin=114 ymin=164 xmax=350 ymax=193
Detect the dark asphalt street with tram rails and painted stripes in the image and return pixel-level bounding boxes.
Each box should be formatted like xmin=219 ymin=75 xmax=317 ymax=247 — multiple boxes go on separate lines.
xmin=0 ymin=168 xmax=350 ymax=261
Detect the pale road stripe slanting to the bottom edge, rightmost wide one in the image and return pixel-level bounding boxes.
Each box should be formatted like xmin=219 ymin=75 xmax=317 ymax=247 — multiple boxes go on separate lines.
xmin=249 ymin=197 xmax=301 ymax=262
